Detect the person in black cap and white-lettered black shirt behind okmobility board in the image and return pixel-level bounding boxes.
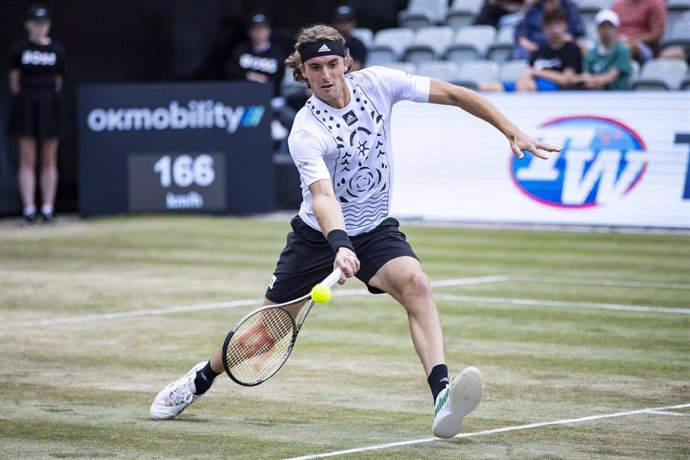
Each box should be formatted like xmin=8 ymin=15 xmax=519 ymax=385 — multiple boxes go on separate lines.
xmin=226 ymin=13 xmax=285 ymax=97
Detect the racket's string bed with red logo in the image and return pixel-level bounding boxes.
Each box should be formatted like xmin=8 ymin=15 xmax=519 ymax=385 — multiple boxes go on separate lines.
xmin=225 ymin=308 xmax=294 ymax=384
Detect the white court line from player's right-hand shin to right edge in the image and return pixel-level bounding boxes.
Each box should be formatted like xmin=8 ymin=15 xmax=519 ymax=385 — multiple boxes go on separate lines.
xmin=434 ymin=294 xmax=690 ymax=315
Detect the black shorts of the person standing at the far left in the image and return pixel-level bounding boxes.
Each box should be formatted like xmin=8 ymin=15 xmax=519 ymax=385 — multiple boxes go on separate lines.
xmin=9 ymin=89 xmax=64 ymax=139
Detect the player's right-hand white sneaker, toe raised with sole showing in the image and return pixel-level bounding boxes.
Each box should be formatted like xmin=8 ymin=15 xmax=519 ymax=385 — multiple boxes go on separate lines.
xmin=432 ymin=367 xmax=484 ymax=438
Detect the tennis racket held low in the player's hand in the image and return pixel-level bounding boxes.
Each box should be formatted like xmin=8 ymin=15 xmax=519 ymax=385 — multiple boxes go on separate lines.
xmin=223 ymin=268 xmax=341 ymax=387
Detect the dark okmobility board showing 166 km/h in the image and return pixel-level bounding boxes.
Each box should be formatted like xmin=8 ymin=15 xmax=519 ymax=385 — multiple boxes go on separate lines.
xmin=78 ymin=83 xmax=275 ymax=216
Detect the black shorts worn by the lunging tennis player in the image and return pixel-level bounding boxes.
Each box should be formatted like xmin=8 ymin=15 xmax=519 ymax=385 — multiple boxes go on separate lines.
xmin=266 ymin=216 xmax=418 ymax=303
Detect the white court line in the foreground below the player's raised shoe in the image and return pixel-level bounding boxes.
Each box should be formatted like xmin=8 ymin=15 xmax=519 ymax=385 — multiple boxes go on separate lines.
xmin=288 ymin=404 xmax=690 ymax=460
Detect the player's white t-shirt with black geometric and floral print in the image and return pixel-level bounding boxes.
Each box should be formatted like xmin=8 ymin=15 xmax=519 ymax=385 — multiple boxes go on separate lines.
xmin=288 ymin=67 xmax=430 ymax=236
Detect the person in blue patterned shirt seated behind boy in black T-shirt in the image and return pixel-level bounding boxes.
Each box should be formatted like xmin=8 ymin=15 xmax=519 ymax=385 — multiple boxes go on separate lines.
xmin=512 ymin=0 xmax=585 ymax=59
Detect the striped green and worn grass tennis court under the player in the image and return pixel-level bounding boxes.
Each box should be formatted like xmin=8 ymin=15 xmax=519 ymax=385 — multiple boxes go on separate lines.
xmin=0 ymin=216 xmax=690 ymax=459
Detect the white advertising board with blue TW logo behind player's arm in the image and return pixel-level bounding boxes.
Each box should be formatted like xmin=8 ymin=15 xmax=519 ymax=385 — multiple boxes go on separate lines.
xmin=392 ymin=92 xmax=690 ymax=228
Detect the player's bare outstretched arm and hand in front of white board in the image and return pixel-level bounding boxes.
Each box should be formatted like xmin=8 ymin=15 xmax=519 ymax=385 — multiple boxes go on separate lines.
xmin=429 ymin=79 xmax=561 ymax=159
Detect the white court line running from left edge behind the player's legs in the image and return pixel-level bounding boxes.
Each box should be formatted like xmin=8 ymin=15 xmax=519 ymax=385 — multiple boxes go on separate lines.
xmin=0 ymin=276 xmax=509 ymax=330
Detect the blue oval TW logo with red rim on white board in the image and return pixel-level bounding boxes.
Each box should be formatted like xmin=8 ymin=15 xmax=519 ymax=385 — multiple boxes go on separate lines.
xmin=512 ymin=116 xmax=648 ymax=208
